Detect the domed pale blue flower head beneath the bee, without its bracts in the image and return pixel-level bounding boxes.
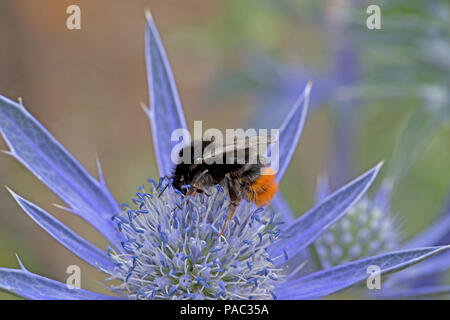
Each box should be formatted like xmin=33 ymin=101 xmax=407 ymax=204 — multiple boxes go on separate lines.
xmin=103 ymin=184 xmax=284 ymax=299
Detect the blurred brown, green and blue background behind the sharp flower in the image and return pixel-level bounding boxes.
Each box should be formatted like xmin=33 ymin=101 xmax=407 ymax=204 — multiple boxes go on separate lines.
xmin=0 ymin=0 xmax=450 ymax=299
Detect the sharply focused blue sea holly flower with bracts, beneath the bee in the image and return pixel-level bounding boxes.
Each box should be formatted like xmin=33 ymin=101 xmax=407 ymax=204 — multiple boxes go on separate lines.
xmin=0 ymin=13 xmax=448 ymax=299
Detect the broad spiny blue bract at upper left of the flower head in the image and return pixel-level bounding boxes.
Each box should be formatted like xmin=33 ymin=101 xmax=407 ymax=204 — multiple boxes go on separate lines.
xmin=0 ymin=96 xmax=120 ymax=250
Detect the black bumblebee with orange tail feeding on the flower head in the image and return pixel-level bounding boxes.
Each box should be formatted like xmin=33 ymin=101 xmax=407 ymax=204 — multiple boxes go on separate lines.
xmin=165 ymin=136 xmax=278 ymax=237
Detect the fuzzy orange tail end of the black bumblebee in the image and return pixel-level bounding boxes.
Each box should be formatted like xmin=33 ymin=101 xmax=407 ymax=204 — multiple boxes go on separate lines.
xmin=246 ymin=167 xmax=278 ymax=207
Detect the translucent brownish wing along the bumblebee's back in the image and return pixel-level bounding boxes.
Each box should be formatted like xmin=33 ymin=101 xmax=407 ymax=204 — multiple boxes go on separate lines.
xmin=203 ymin=136 xmax=275 ymax=160
